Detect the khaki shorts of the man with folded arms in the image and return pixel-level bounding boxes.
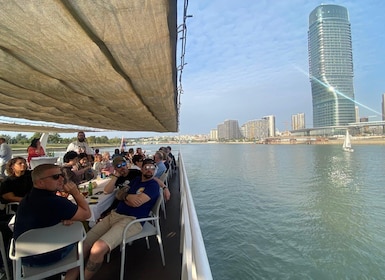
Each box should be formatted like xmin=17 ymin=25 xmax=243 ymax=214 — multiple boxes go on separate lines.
xmin=84 ymin=211 xmax=142 ymax=251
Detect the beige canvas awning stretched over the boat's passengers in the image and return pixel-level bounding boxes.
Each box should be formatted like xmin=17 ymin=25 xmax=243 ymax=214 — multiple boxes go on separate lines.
xmin=0 ymin=0 xmax=179 ymax=132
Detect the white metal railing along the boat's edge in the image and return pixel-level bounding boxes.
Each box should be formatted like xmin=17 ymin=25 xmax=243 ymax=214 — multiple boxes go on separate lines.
xmin=178 ymin=153 xmax=213 ymax=280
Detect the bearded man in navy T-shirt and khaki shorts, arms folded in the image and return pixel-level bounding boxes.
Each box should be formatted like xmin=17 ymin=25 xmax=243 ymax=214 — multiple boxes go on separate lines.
xmin=66 ymin=159 xmax=159 ymax=279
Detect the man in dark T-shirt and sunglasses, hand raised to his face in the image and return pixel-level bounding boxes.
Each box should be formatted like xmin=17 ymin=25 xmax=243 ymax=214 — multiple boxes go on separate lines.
xmin=13 ymin=164 xmax=91 ymax=266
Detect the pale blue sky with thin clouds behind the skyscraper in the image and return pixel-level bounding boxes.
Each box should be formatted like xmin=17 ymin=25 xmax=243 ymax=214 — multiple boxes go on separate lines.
xmin=1 ymin=0 xmax=385 ymax=137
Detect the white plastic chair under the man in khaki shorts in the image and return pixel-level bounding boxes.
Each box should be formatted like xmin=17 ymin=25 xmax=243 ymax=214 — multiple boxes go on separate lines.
xmin=120 ymin=191 xmax=166 ymax=280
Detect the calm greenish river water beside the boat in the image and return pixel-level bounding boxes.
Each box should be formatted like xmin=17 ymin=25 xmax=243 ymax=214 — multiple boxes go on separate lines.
xmin=179 ymin=144 xmax=385 ymax=279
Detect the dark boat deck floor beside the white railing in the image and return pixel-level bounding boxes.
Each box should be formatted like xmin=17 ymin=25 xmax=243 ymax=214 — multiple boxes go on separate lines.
xmin=93 ymin=172 xmax=182 ymax=280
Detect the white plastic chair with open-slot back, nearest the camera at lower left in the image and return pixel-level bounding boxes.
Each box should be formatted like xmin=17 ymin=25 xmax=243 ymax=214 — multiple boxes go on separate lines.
xmin=9 ymin=222 xmax=86 ymax=280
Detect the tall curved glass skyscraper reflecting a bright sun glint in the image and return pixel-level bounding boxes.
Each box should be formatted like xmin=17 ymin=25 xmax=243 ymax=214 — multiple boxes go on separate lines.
xmin=308 ymin=5 xmax=356 ymax=127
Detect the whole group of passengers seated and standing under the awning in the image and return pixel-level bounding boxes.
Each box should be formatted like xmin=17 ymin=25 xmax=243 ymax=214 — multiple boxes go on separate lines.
xmin=0 ymin=132 xmax=175 ymax=279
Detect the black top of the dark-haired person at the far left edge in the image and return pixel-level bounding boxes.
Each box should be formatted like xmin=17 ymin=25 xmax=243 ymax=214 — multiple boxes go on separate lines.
xmin=0 ymin=170 xmax=33 ymax=203
